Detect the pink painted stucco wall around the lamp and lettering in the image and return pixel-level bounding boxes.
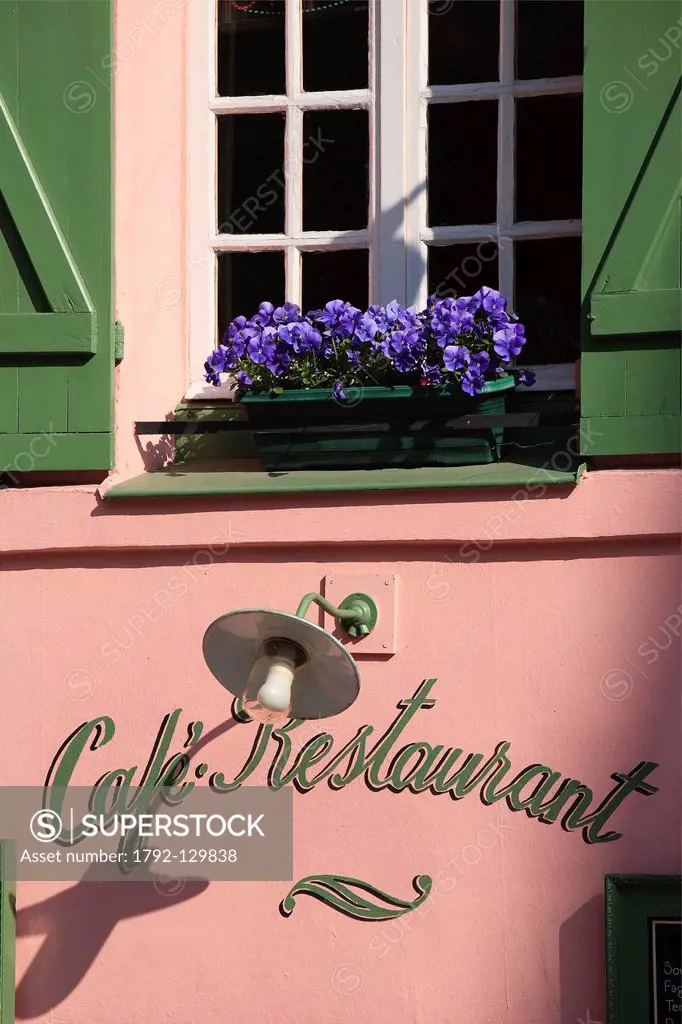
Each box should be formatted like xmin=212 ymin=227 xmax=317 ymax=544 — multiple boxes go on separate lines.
xmin=0 ymin=0 xmax=681 ymax=1024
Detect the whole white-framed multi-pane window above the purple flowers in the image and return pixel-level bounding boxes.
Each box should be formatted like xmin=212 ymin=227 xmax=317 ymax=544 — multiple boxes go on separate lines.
xmin=187 ymin=0 xmax=583 ymax=397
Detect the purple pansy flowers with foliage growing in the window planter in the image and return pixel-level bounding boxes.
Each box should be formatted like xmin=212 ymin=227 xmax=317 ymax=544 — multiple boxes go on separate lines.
xmin=205 ymin=288 xmax=534 ymax=397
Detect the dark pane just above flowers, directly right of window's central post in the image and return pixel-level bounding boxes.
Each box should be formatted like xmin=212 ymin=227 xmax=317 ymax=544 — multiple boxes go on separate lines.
xmin=427 ymin=240 xmax=498 ymax=299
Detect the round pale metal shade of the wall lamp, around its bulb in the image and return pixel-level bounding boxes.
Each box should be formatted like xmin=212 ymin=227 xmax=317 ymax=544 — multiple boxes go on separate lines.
xmin=204 ymin=608 xmax=359 ymax=718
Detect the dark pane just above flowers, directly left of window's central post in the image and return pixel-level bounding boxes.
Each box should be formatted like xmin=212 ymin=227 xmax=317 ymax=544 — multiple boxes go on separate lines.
xmin=301 ymin=249 xmax=370 ymax=312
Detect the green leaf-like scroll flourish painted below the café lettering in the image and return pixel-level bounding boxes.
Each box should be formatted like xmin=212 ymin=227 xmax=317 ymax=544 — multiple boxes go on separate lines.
xmin=280 ymin=874 xmax=433 ymax=921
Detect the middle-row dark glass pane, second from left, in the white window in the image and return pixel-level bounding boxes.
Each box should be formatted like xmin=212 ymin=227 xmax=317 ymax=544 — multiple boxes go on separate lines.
xmin=303 ymin=111 xmax=370 ymax=231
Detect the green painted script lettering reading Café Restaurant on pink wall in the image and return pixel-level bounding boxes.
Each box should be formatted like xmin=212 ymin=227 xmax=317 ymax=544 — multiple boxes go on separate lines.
xmin=44 ymin=679 xmax=657 ymax=843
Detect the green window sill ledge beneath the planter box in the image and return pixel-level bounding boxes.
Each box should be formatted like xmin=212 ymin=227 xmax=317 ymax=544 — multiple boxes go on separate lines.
xmin=106 ymin=457 xmax=585 ymax=500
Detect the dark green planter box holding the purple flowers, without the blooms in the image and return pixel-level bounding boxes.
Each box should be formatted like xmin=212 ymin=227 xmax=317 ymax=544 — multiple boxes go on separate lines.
xmin=241 ymin=377 xmax=514 ymax=471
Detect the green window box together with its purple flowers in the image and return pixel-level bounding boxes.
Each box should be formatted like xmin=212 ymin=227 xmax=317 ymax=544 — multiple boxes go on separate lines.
xmin=206 ymin=288 xmax=532 ymax=471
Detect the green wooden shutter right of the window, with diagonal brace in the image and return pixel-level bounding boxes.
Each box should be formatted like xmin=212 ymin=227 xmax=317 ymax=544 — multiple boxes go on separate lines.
xmin=581 ymin=0 xmax=682 ymax=455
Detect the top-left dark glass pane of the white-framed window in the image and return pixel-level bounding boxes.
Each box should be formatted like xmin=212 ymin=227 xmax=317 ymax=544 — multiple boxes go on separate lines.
xmin=215 ymin=0 xmax=287 ymax=96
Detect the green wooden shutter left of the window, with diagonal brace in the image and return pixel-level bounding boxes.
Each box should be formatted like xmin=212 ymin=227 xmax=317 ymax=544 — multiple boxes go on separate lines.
xmin=0 ymin=0 xmax=114 ymax=473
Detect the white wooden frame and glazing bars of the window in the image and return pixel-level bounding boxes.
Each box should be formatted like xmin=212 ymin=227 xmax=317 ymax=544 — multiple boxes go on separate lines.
xmin=185 ymin=0 xmax=583 ymax=400
